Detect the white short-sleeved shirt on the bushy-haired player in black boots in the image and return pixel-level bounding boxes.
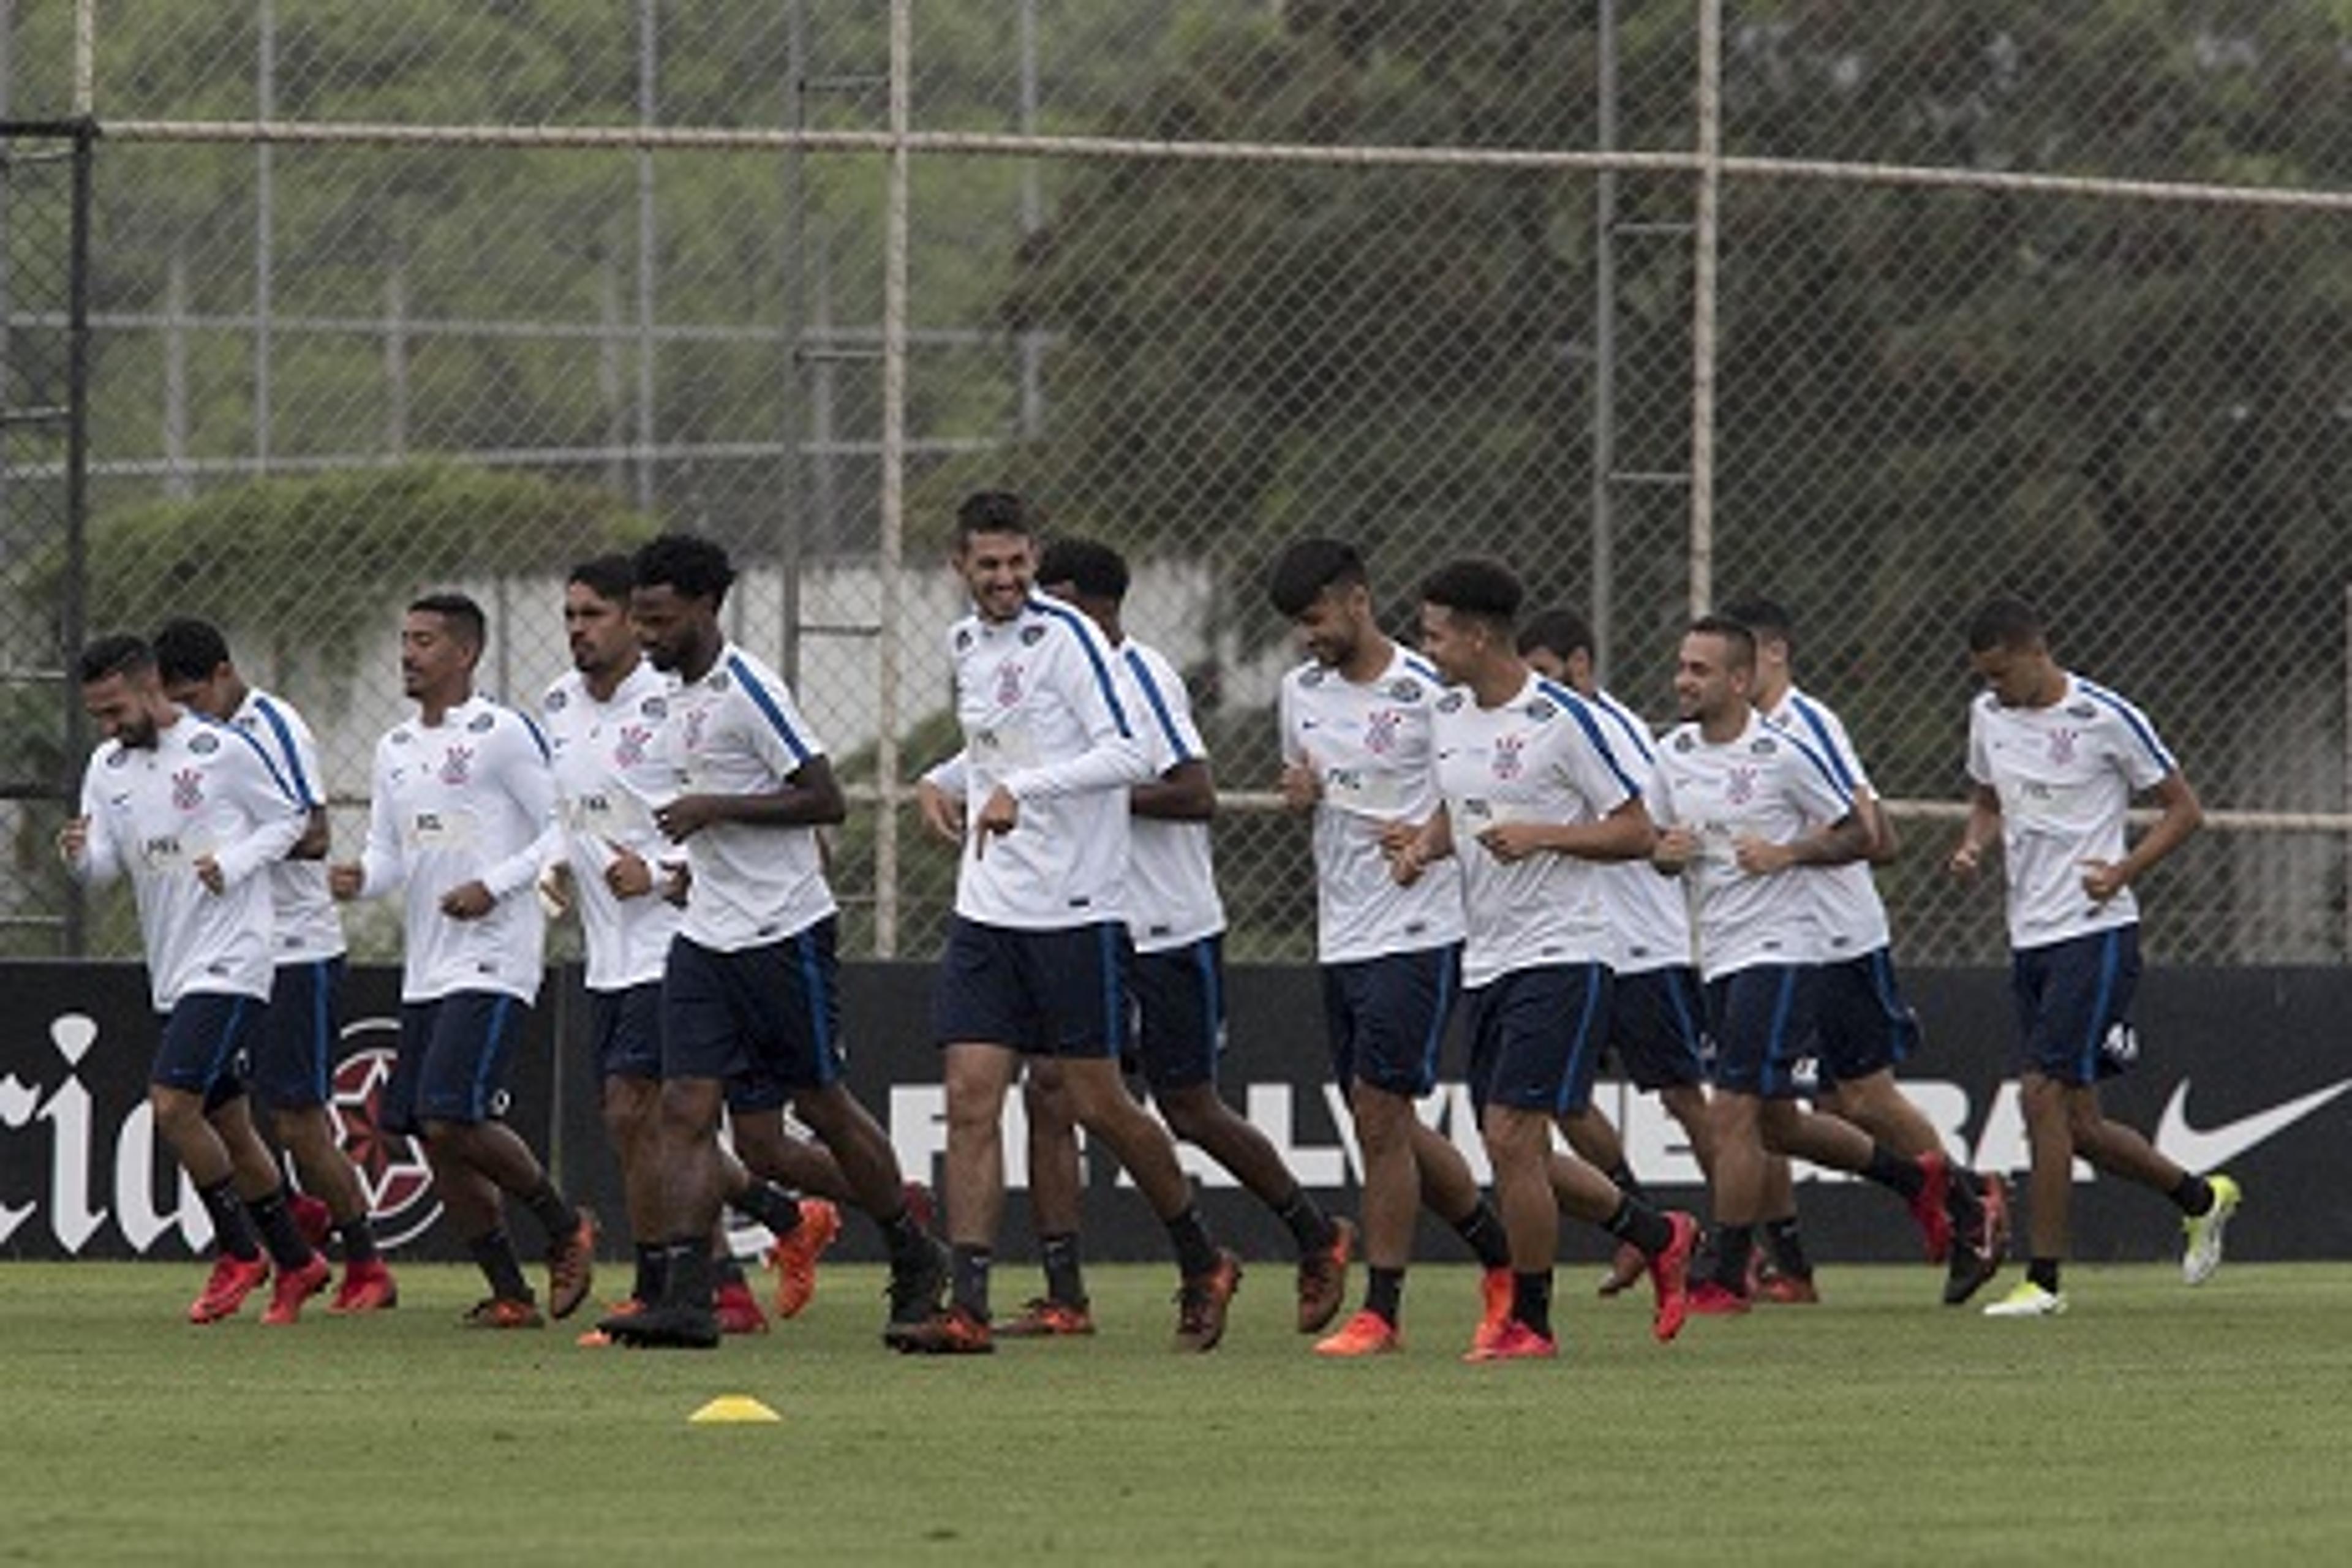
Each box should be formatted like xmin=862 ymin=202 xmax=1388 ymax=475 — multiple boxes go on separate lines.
xmin=661 ymin=642 xmax=835 ymax=952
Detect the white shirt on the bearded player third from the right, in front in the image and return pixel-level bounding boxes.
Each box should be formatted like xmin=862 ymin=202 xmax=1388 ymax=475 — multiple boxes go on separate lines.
xmin=1651 ymin=707 xmax=1853 ymax=980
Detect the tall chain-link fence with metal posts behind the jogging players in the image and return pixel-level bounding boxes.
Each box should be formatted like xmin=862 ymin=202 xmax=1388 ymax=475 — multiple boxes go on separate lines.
xmin=0 ymin=0 xmax=2352 ymax=962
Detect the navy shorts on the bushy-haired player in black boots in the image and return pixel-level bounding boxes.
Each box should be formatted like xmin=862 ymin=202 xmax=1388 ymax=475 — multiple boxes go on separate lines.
xmin=661 ymin=914 xmax=846 ymax=1110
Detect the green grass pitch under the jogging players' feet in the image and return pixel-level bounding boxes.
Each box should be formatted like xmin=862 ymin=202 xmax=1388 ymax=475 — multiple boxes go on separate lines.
xmin=0 ymin=1262 xmax=2352 ymax=1568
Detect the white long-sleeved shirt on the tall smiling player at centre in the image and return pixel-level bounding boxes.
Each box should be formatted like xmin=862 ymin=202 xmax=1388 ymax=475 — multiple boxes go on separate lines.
xmin=929 ymin=595 xmax=1153 ymax=931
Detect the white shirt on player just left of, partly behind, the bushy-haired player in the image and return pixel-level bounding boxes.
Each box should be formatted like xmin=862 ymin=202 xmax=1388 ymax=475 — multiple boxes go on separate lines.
xmin=538 ymin=658 xmax=687 ymax=992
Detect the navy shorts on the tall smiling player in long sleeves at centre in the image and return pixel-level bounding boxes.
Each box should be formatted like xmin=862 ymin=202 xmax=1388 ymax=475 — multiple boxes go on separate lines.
xmin=932 ymin=914 xmax=1134 ymax=1058
